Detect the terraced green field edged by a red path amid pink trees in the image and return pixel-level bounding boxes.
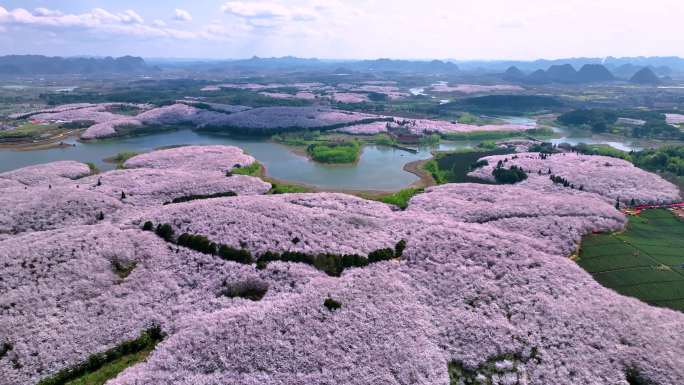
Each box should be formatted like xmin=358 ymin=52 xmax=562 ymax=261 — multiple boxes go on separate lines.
xmin=577 ymin=209 xmax=684 ymax=311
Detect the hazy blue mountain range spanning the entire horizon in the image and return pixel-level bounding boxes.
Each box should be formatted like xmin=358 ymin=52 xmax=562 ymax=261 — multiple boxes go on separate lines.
xmin=0 ymin=55 xmax=684 ymax=78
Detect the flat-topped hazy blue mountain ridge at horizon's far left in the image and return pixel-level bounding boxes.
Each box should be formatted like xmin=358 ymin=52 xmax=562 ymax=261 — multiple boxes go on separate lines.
xmin=0 ymin=55 xmax=152 ymax=75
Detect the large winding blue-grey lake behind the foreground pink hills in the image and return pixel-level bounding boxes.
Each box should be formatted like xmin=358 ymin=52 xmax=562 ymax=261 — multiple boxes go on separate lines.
xmin=0 ymin=129 xmax=474 ymax=191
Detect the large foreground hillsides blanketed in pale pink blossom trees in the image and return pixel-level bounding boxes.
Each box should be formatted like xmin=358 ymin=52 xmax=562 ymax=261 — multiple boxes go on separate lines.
xmin=0 ymin=145 xmax=684 ymax=385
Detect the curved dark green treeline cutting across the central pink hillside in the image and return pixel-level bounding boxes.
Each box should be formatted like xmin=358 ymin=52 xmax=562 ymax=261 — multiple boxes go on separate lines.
xmin=143 ymin=221 xmax=406 ymax=277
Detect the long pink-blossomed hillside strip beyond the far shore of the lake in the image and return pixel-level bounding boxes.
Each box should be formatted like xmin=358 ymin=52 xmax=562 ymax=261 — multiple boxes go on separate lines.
xmin=12 ymin=101 xmax=537 ymax=140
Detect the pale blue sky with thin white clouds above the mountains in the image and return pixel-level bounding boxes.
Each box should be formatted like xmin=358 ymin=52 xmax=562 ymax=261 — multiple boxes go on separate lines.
xmin=0 ymin=0 xmax=684 ymax=59
